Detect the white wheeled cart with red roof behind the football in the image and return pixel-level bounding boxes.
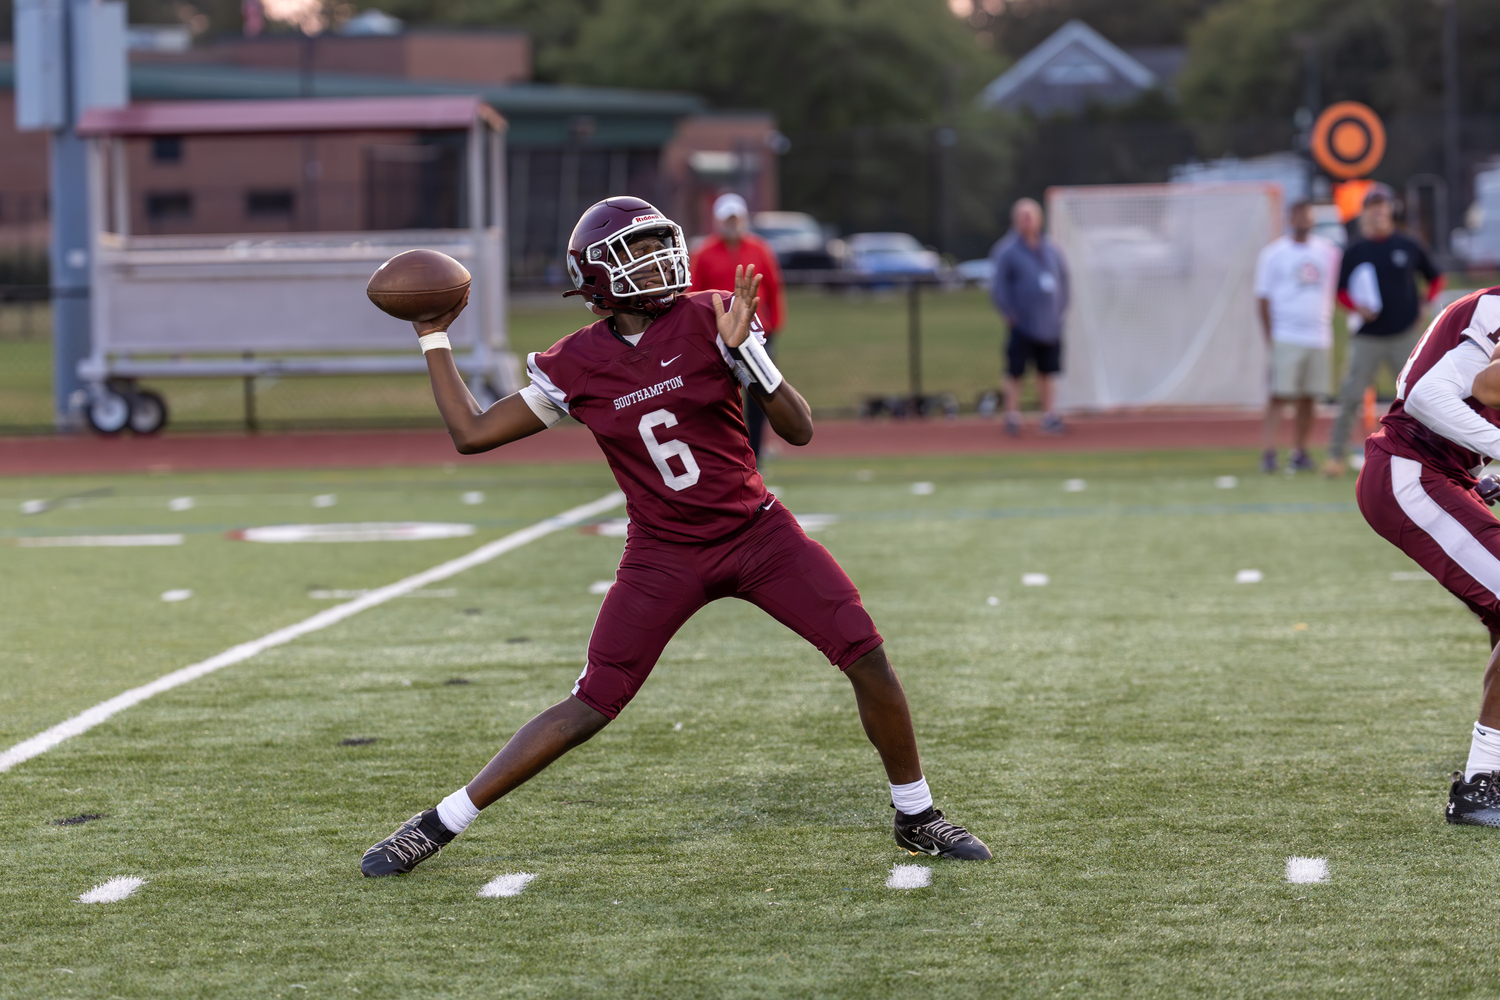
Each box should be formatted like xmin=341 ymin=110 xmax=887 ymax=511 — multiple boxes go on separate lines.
xmin=78 ymin=96 xmax=521 ymax=433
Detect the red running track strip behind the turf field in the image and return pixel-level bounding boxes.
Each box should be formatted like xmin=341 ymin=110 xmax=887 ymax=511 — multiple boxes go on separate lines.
xmin=0 ymin=411 xmax=1329 ymax=475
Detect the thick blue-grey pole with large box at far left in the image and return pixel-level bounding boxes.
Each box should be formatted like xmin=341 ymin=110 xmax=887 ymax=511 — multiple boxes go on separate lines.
xmin=15 ymin=0 xmax=129 ymax=430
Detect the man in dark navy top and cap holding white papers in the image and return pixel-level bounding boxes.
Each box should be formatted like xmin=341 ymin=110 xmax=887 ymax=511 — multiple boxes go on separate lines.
xmin=1323 ymin=184 xmax=1443 ymax=475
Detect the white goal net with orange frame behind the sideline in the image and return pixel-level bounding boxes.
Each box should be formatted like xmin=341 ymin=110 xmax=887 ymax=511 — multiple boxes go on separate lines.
xmin=1047 ymin=183 xmax=1281 ymax=411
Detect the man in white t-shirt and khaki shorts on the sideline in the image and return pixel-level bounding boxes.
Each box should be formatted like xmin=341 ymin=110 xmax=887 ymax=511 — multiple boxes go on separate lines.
xmin=1256 ymin=201 xmax=1341 ymax=472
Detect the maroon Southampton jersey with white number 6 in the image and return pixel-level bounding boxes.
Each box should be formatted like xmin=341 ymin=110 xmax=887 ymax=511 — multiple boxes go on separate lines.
xmin=528 ymin=292 xmax=771 ymax=541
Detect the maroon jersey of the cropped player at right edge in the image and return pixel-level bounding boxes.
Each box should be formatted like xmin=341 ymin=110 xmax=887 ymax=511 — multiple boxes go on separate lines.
xmin=1374 ymin=288 xmax=1500 ymax=486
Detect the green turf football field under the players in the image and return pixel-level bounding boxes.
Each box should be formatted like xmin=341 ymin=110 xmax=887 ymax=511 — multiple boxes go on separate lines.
xmin=0 ymin=453 xmax=1500 ymax=999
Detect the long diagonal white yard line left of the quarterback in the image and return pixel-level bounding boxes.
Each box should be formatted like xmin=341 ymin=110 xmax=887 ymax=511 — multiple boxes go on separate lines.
xmin=0 ymin=490 xmax=626 ymax=772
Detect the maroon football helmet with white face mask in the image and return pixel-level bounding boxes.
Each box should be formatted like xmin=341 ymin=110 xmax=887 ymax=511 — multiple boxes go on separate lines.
xmin=563 ymin=196 xmax=692 ymax=316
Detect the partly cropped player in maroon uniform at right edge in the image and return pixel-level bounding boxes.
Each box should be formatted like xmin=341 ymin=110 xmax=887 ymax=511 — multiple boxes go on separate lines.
xmin=1356 ymin=288 xmax=1500 ymax=826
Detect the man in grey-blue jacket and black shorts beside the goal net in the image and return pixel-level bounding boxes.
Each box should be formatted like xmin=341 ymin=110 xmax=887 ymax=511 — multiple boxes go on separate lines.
xmin=990 ymin=198 xmax=1068 ymax=435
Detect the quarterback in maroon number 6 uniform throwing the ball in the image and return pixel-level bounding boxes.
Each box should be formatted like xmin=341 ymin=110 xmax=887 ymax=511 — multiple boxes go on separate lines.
xmin=360 ymin=198 xmax=990 ymax=876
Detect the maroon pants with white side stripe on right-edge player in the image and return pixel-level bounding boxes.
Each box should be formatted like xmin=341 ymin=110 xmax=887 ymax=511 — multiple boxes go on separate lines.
xmin=1355 ymin=444 xmax=1500 ymax=631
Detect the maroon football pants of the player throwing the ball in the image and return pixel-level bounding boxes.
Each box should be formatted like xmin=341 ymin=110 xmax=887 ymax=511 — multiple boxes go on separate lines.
xmin=573 ymin=501 xmax=882 ymax=718
